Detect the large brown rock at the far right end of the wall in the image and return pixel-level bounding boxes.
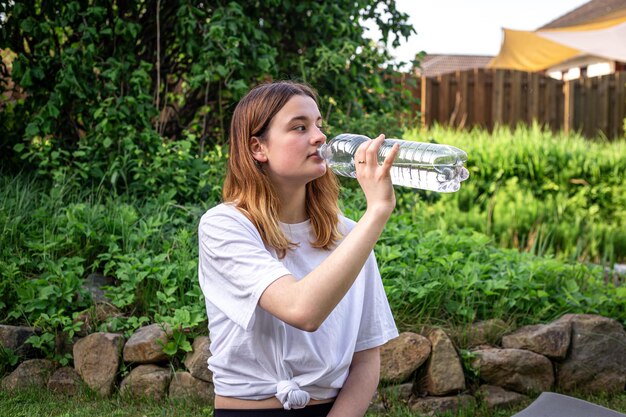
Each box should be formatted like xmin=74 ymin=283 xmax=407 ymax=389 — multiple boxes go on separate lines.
xmin=556 ymin=314 xmax=626 ymax=393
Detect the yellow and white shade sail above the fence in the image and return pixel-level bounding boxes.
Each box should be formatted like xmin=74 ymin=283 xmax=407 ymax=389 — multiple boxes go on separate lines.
xmin=489 ymin=10 xmax=626 ymax=71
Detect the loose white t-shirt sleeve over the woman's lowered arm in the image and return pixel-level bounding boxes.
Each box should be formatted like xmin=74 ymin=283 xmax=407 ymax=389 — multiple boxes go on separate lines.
xmin=354 ymin=252 xmax=398 ymax=352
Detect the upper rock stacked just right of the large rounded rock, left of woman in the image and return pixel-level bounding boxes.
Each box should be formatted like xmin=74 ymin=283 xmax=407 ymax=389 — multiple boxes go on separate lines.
xmin=124 ymin=324 xmax=171 ymax=363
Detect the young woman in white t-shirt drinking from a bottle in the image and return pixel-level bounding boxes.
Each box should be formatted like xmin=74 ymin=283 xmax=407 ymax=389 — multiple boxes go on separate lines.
xmin=198 ymin=82 xmax=398 ymax=417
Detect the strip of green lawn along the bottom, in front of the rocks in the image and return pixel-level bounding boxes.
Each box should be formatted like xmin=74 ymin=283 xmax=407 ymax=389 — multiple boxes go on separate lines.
xmin=0 ymin=389 xmax=626 ymax=417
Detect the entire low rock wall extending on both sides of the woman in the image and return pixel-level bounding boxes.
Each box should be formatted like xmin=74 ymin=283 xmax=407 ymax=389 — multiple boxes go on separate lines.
xmin=0 ymin=314 xmax=626 ymax=414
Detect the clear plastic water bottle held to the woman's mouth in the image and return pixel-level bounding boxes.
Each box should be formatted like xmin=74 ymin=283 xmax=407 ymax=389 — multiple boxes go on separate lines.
xmin=318 ymin=133 xmax=469 ymax=193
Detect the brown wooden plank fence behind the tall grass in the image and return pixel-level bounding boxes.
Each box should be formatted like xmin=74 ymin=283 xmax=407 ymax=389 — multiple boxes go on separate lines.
xmin=416 ymin=69 xmax=626 ymax=138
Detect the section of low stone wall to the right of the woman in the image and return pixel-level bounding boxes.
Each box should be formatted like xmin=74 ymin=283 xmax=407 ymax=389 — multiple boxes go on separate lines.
xmin=381 ymin=314 xmax=626 ymax=414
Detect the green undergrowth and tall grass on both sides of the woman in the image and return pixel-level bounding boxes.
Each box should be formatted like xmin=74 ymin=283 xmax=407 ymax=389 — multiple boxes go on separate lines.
xmin=0 ymin=122 xmax=626 ymax=364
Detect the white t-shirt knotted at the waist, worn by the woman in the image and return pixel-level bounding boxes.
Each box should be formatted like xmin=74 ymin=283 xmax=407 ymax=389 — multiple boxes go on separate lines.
xmin=198 ymin=204 xmax=398 ymax=409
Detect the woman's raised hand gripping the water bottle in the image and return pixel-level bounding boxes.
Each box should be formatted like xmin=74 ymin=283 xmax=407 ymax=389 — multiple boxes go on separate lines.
xmin=354 ymin=135 xmax=399 ymax=221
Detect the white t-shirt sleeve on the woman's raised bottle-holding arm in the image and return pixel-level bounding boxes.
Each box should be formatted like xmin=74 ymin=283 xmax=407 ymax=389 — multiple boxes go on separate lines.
xmin=198 ymin=205 xmax=290 ymax=330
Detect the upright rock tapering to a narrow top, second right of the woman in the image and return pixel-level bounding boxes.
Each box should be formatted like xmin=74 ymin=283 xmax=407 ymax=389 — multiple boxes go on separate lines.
xmin=415 ymin=329 xmax=465 ymax=396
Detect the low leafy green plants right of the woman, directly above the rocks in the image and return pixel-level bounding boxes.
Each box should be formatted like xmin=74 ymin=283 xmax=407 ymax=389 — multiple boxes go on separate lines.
xmin=376 ymin=210 xmax=626 ymax=329
